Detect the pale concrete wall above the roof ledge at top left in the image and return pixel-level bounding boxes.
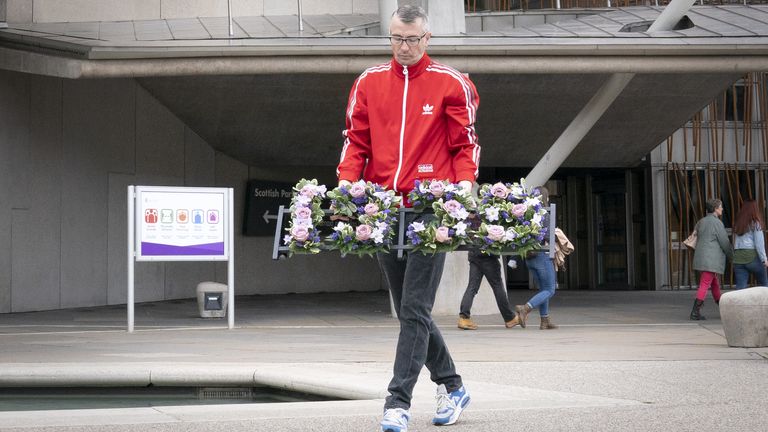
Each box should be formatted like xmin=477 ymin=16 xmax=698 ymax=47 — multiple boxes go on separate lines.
xmin=0 ymin=0 xmax=378 ymax=23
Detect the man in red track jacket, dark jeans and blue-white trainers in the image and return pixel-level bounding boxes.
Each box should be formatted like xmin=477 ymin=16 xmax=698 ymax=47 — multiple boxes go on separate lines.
xmin=337 ymin=6 xmax=480 ymax=432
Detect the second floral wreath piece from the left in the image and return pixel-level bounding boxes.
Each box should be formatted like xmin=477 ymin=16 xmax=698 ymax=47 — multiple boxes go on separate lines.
xmin=326 ymin=180 xmax=401 ymax=256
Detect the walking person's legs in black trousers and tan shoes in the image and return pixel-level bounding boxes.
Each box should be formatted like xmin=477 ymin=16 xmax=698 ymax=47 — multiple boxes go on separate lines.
xmin=459 ymin=249 xmax=518 ymax=330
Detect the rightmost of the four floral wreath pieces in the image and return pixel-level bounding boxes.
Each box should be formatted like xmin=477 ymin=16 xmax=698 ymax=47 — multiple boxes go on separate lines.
xmin=476 ymin=179 xmax=547 ymax=257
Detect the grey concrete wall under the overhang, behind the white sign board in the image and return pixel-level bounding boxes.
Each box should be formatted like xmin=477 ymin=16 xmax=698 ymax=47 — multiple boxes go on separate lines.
xmin=0 ymin=71 xmax=380 ymax=313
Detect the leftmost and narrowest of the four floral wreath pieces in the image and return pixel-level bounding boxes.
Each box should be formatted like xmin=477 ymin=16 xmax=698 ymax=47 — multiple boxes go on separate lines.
xmin=283 ymin=179 xmax=327 ymax=256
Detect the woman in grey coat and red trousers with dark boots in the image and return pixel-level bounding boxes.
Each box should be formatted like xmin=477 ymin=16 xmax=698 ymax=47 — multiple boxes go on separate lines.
xmin=691 ymin=198 xmax=733 ymax=321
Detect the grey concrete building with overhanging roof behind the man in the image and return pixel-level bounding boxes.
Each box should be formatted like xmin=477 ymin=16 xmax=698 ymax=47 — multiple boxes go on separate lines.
xmin=0 ymin=0 xmax=766 ymax=313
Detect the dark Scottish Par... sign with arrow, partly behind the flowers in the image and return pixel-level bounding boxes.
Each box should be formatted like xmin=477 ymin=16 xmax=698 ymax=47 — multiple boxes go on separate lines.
xmin=243 ymin=180 xmax=294 ymax=237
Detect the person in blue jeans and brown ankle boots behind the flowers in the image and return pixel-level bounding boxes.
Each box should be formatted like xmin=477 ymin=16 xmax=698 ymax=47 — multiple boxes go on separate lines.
xmin=515 ymin=186 xmax=557 ymax=330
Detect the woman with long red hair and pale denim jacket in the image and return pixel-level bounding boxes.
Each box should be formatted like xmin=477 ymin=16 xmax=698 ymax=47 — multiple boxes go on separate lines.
xmin=733 ymin=200 xmax=768 ymax=289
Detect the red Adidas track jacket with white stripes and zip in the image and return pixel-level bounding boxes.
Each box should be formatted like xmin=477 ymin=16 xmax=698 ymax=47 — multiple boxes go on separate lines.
xmin=336 ymin=54 xmax=480 ymax=194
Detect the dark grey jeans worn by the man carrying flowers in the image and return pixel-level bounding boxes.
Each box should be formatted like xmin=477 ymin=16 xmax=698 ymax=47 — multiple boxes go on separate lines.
xmin=377 ymin=252 xmax=462 ymax=409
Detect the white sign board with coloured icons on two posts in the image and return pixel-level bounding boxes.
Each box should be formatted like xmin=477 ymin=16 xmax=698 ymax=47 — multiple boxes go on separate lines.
xmin=127 ymin=186 xmax=235 ymax=333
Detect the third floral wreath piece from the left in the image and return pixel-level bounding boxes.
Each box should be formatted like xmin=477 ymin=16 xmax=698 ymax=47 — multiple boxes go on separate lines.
xmin=406 ymin=180 xmax=475 ymax=254
